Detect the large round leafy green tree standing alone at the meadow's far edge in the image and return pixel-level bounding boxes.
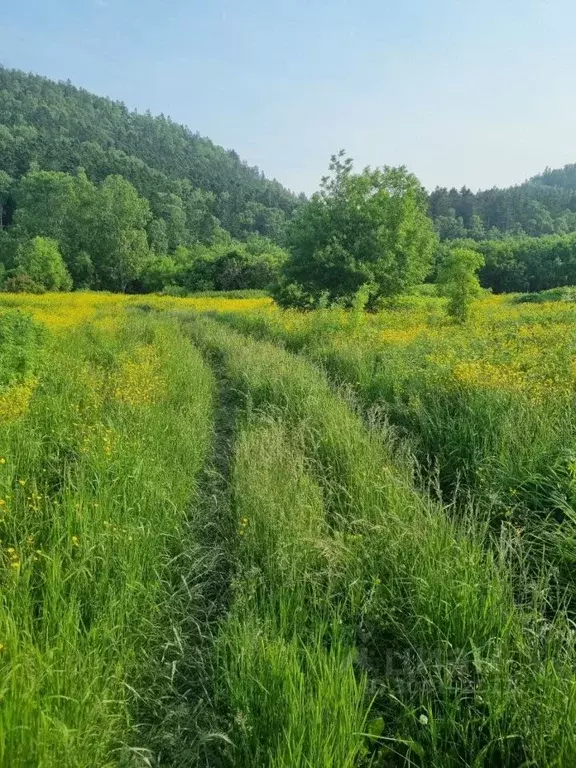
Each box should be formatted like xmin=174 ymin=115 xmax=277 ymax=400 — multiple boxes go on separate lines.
xmin=277 ymin=151 xmax=437 ymax=306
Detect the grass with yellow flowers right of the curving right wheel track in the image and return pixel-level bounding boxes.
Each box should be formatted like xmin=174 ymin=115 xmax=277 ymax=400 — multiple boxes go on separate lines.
xmin=217 ymin=300 xmax=576 ymax=527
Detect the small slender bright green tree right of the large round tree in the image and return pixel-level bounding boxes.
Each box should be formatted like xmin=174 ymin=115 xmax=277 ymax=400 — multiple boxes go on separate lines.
xmin=438 ymin=248 xmax=484 ymax=323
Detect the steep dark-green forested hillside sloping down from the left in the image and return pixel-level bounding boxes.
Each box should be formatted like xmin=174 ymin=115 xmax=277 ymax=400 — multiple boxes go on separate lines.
xmin=0 ymin=67 xmax=298 ymax=242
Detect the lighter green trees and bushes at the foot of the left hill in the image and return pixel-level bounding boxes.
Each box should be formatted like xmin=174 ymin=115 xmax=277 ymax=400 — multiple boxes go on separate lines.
xmin=0 ymin=169 xmax=286 ymax=292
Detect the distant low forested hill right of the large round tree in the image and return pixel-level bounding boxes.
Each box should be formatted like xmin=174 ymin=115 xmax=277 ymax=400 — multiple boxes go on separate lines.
xmin=429 ymin=165 xmax=576 ymax=240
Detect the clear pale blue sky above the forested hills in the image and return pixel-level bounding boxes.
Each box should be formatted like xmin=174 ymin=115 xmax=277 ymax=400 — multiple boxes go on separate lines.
xmin=0 ymin=0 xmax=576 ymax=192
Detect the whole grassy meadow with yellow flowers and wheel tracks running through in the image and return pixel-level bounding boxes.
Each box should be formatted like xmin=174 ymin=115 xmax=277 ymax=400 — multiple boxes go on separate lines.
xmin=0 ymin=293 xmax=576 ymax=768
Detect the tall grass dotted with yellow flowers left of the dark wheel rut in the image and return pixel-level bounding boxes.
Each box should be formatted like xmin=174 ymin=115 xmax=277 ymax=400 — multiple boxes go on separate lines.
xmin=0 ymin=314 xmax=213 ymax=768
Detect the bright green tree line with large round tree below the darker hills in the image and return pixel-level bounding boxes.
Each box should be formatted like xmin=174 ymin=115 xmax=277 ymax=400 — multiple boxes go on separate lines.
xmin=0 ymin=160 xmax=576 ymax=302
